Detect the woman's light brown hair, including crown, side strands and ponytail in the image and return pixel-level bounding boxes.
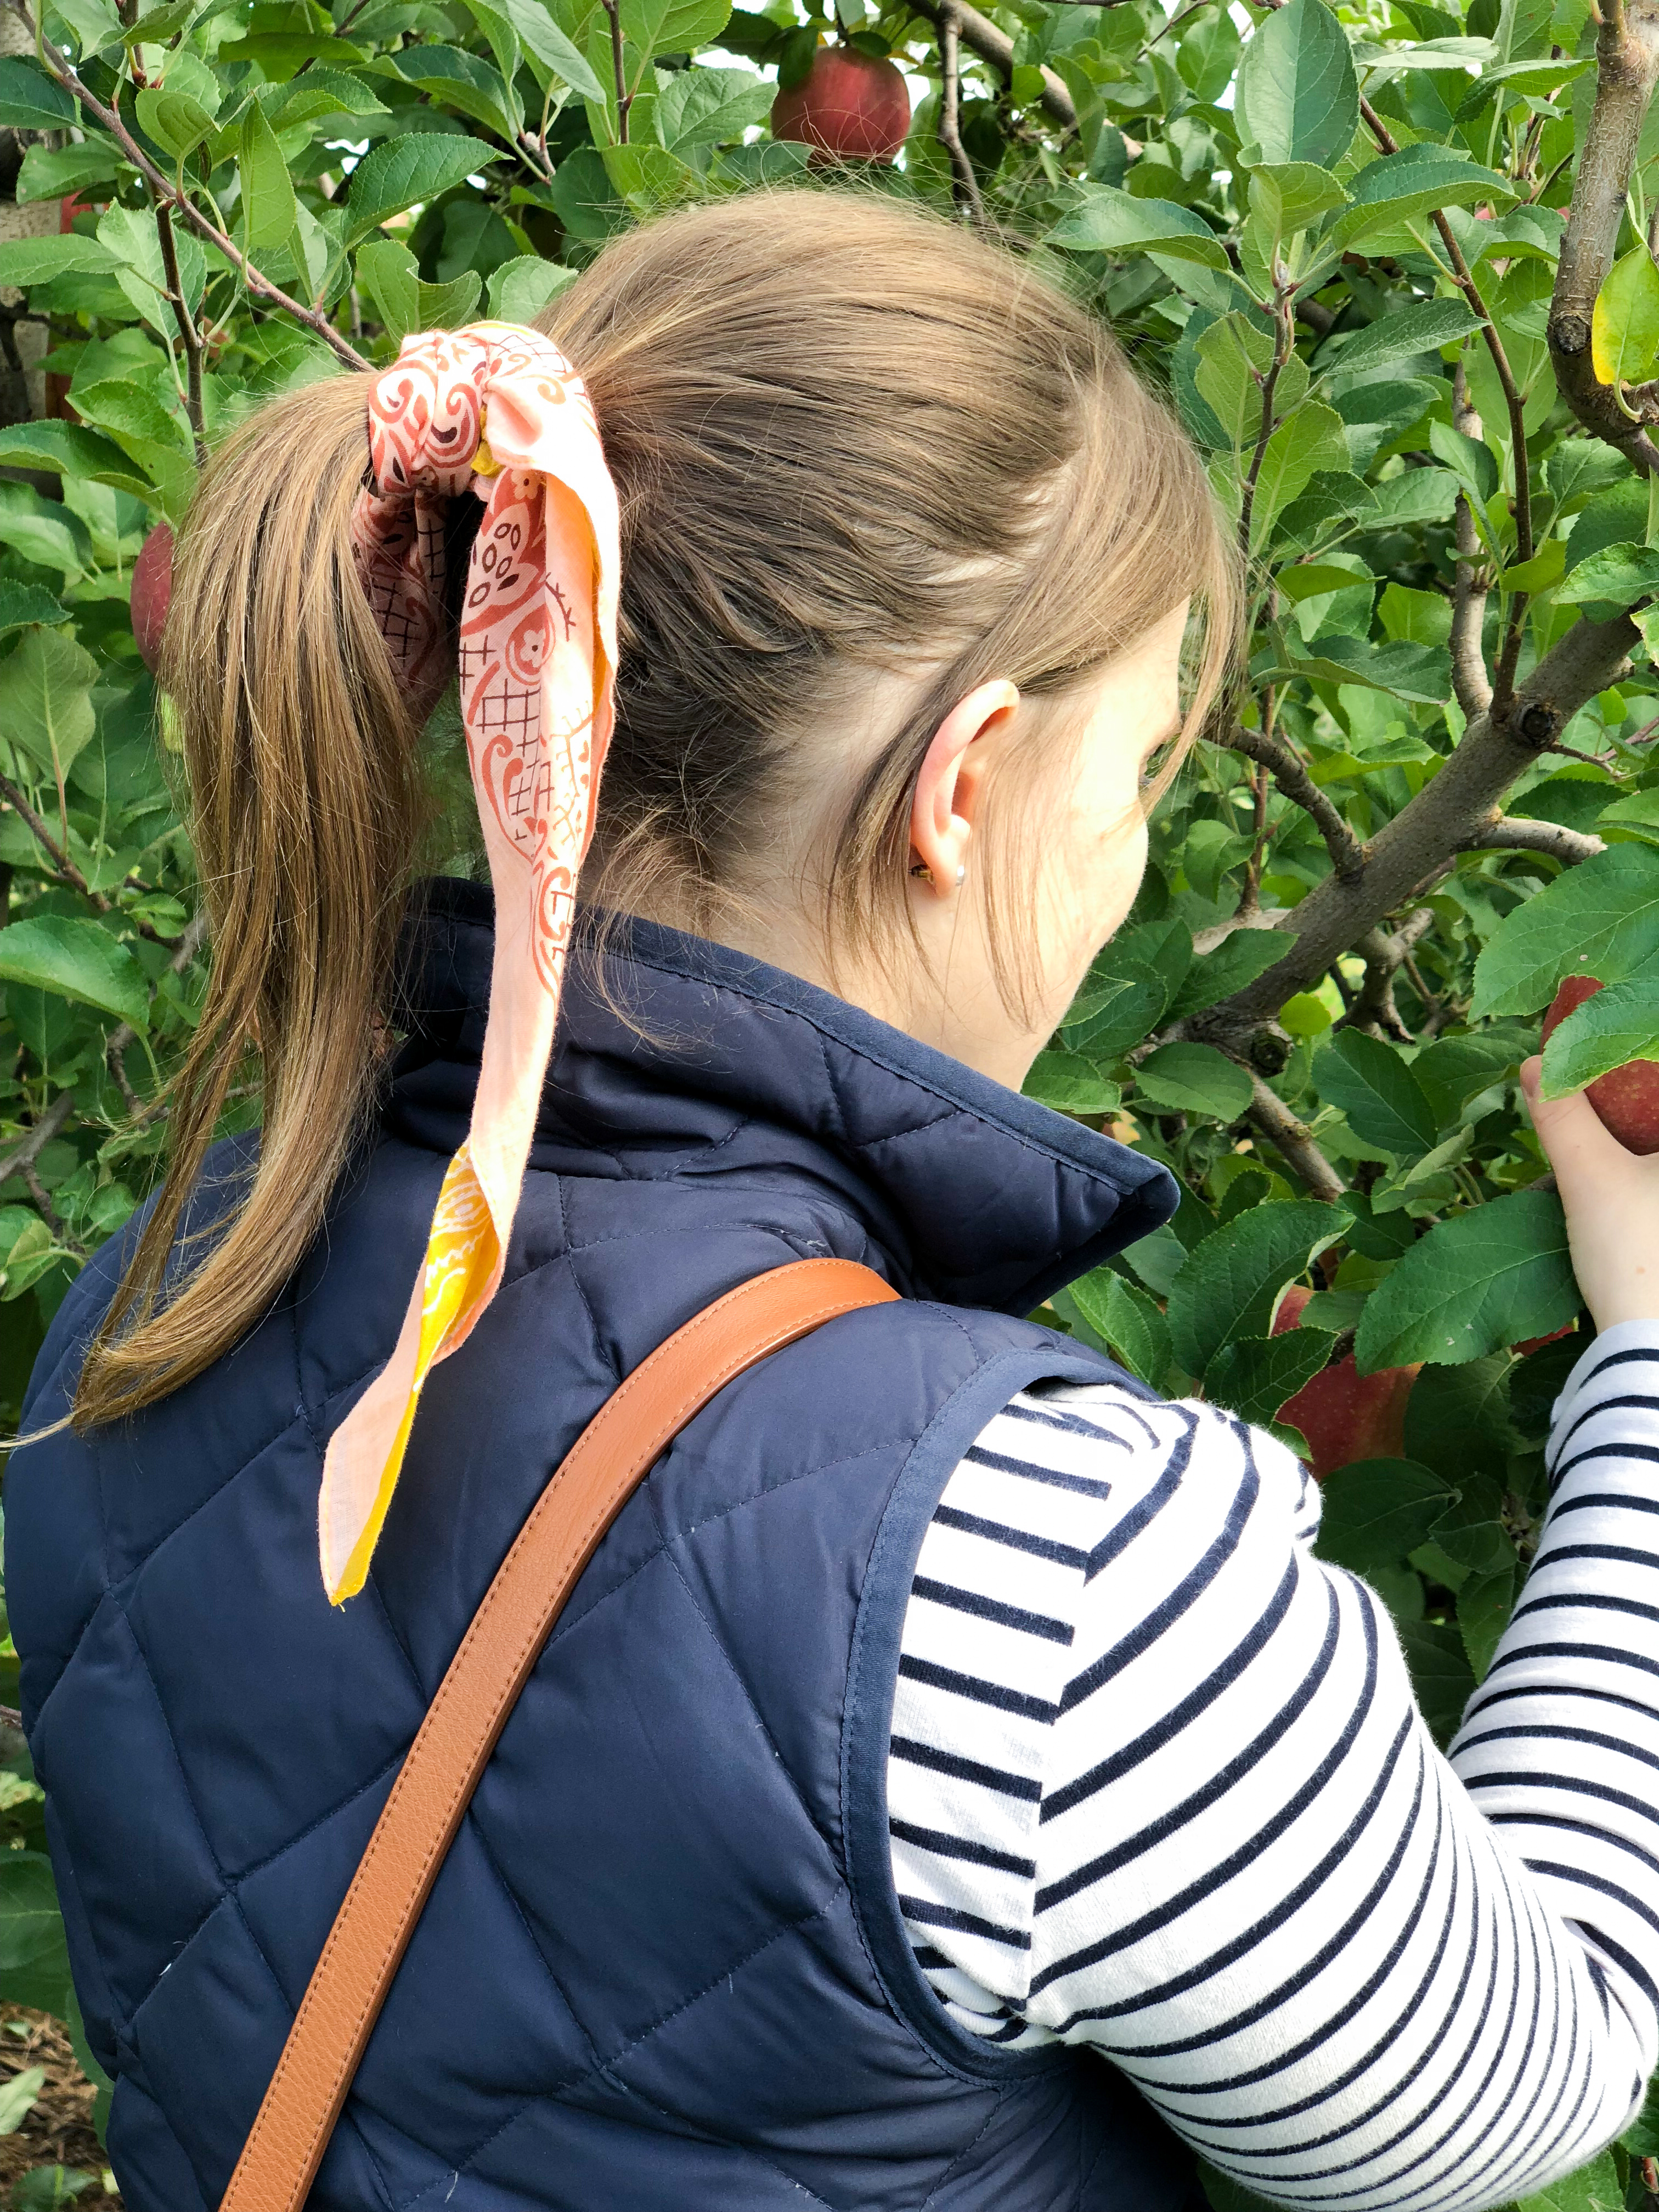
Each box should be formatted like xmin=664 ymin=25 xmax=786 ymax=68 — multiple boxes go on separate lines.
xmin=73 ymin=190 xmax=1237 ymax=1427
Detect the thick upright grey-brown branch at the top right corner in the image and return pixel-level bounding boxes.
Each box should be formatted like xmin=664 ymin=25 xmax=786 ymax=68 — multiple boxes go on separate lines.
xmin=1548 ymin=0 xmax=1659 ymax=462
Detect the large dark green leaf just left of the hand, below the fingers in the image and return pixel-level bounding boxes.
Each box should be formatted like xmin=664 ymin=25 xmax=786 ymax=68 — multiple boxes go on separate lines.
xmin=1354 ymin=1190 xmax=1579 ymax=1374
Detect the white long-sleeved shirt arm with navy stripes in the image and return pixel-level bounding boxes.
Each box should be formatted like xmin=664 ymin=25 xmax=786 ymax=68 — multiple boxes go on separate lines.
xmin=887 ymin=1323 xmax=1659 ymax=2212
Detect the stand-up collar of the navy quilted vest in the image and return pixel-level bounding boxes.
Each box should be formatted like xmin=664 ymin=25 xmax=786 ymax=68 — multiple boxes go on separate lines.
xmin=387 ymin=878 xmax=1179 ymax=1314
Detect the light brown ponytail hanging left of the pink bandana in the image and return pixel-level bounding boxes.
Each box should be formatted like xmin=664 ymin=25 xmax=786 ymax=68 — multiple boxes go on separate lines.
xmin=71 ymin=376 xmax=425 ymax=1429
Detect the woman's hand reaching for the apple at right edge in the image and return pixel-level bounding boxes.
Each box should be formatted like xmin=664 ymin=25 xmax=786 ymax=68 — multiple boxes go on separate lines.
xmin=1520 ymin=1059 xmax=1659 ymax=1329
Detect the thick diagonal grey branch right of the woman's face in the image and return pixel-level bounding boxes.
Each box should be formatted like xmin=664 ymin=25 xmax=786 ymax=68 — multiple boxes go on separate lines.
xmin=1186 ymin=615 xmax=1637 ymax=1051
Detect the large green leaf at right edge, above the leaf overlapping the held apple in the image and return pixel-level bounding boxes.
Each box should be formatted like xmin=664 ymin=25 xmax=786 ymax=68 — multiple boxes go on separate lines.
xmin=1471 ymin=845 xmax=1659 ymax=1017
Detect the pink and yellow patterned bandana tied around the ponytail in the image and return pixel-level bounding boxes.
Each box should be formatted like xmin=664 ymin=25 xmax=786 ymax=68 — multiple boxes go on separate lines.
xmin=319 ymin=323 xmax=619 ymax=1604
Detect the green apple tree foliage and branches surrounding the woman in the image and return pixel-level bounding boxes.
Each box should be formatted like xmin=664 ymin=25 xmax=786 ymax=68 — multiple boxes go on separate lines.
xmin=0 ymin=0 xmax=1659 ymax=2185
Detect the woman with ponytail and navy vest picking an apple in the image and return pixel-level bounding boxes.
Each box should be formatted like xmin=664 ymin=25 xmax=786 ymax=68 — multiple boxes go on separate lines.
xmin=7 ymin=193 xmax=1659 ymax=2212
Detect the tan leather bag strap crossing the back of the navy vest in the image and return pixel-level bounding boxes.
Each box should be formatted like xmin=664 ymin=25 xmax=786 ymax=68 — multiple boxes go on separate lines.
xmin=221 ymin=1259 xmax=898 ymax=2212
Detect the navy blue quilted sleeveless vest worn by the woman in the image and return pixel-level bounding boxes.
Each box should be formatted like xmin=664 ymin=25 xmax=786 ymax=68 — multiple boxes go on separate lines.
xmin=7 ymin=883 xmax=1190 ymax=2212
